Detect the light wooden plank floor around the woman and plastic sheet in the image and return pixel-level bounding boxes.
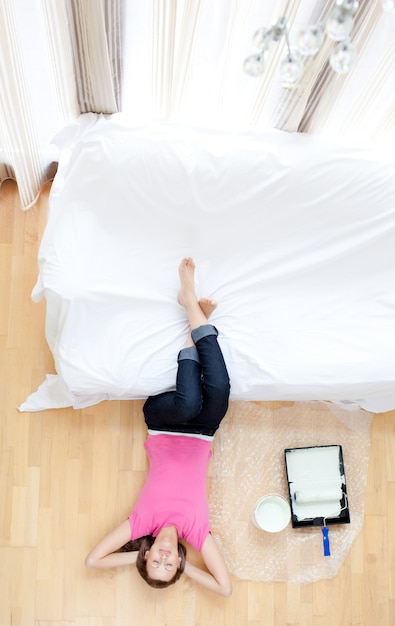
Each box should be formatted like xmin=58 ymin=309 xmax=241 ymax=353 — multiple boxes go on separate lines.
xmin=0 ymin=177 xmax=395 ymax=626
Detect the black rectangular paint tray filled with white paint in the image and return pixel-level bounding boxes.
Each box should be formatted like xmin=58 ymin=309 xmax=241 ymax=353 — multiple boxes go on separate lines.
xmin=284 ymin=445 xmax=350 ymax=528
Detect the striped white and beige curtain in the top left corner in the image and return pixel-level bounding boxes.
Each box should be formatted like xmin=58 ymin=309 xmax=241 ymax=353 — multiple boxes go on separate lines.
xmin=0 ymin=0 xmax=121 ymax=208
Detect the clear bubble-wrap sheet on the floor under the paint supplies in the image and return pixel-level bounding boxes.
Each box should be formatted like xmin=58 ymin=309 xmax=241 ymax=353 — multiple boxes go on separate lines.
xmin=209 ymin=402 xmax=372 ymax=583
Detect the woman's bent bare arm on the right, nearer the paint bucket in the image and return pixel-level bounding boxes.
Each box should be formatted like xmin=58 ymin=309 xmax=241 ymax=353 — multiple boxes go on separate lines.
xmin=185 ymin=534 xmax=232 ymax=598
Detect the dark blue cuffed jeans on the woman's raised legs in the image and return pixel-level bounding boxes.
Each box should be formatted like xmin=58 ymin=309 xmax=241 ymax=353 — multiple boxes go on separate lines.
xmin=143 ymin=324 xmax=230 ymax=435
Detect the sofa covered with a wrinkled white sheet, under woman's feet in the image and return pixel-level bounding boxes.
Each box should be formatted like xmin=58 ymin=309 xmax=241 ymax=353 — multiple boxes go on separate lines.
xmin=19 ymin=113 xmax=395 ymax=412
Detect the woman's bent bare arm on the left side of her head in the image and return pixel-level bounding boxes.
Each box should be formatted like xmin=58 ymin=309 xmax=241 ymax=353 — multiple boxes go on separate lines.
xmin=85 ymin=520 xmax=137 ymax=568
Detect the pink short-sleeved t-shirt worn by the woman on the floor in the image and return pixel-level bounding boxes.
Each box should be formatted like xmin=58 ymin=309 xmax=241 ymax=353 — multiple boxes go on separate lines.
xmin=129 ymin=435 xmax=212 ymax=552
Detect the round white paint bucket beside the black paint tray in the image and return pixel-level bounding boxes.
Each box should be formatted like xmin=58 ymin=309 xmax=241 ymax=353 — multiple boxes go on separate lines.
xmin=251 ymin=493 xmax=291 ymax=533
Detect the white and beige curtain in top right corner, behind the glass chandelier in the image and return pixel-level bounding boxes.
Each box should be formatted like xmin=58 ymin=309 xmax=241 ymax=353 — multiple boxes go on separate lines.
xmin=298 ymin=0 xmax=395 ymax=139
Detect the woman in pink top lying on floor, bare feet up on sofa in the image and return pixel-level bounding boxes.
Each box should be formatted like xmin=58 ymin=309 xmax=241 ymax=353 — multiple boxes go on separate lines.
xmin=85 ymin=257 xmax=232 ymax=597
